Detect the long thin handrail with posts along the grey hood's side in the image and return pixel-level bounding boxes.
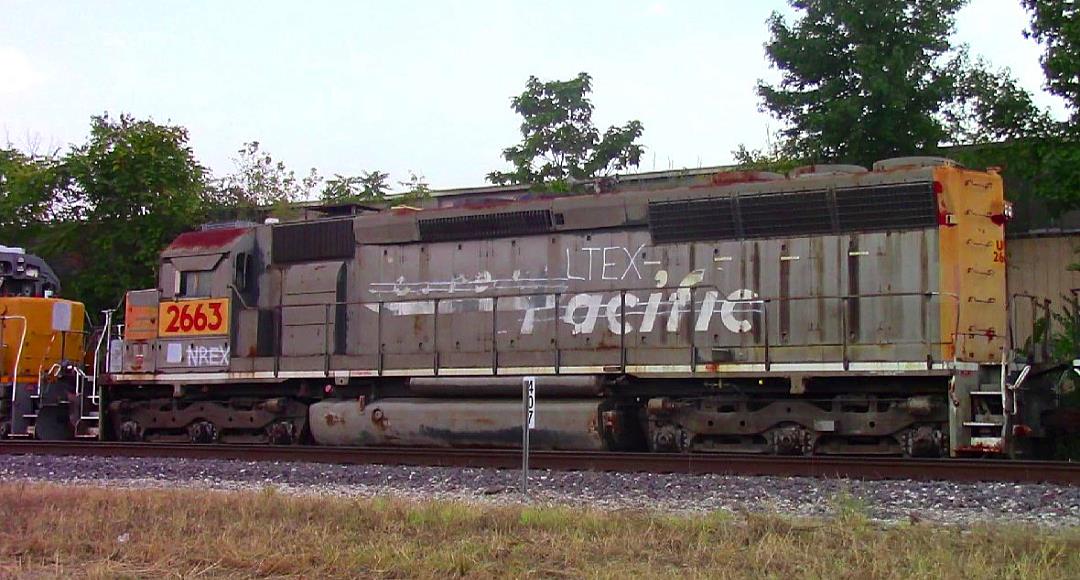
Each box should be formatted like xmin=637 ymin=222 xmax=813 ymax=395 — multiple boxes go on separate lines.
xmin=254 ymin=284 xmax=963 ymax=377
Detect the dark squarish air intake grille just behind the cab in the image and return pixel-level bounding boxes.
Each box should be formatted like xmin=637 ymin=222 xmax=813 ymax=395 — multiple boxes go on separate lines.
xmin=271 ymin=219 xmax=356 ymax=264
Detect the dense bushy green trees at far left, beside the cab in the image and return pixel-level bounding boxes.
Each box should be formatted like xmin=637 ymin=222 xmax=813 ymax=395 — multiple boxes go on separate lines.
xmin=0 ymin=114 xmax=215 ymax=313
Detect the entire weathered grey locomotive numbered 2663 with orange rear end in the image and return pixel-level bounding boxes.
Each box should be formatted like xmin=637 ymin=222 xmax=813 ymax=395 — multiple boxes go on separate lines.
xmin=90 ymin=158 xmax=1053 ymax=456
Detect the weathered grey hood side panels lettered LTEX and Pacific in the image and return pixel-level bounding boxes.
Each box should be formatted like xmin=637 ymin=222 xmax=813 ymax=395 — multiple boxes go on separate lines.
xmin=346 ymin=229 xmax=942 ymax=369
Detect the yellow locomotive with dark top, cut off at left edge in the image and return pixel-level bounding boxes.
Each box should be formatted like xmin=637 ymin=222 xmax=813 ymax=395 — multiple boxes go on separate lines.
xmin=0 ymin=246 xmax=100 ymax=440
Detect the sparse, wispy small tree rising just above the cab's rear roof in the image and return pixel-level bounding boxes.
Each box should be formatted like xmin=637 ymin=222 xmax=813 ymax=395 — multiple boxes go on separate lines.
xmin=218 ymin=141 xmax=322 ymax=208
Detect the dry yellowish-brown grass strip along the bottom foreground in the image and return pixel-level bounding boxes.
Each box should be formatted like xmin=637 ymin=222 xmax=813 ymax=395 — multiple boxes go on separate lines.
xmin=0 ymin=484 xmax=1080 ymax=579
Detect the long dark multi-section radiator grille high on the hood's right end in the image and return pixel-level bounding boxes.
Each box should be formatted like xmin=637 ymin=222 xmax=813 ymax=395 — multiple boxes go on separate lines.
xmin=649 ymin=181 xmax=937 ymax=243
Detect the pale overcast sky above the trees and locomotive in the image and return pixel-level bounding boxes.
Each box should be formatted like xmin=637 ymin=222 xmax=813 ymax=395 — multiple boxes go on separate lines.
xmin=0 ymin=0 xmax=1063 ymax=189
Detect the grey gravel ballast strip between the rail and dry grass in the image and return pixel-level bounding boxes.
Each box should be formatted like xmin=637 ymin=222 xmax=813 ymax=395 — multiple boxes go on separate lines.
xmin=0 ymin=456 xmax=1080 ymax=526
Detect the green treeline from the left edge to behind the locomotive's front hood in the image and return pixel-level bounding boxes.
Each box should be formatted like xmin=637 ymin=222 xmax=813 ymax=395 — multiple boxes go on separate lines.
xmin=0 ymin=114 xmax=430 ymax=319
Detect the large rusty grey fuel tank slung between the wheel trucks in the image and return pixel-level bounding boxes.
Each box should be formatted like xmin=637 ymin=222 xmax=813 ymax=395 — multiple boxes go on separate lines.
xmin=309 ymin=399 xmax=607 ymax=450
